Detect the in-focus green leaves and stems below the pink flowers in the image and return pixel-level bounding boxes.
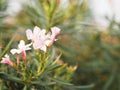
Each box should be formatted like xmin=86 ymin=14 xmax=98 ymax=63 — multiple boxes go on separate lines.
xmin=0 ymin=42 xmax=92 ymax=90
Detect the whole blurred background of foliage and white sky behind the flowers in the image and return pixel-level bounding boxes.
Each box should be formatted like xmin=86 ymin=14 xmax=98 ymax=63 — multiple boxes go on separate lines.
xmin=0 ymin=0 xmax=120 ymax=90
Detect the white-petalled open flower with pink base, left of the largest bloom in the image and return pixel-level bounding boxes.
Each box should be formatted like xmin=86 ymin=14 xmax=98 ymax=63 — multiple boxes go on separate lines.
xmin=10 ymin=40 xmax=31 ymax=56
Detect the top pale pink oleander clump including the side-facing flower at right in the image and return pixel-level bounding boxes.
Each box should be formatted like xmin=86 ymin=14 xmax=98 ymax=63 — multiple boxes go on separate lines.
xmin=26 ymin=26 xmax=60 ymax=52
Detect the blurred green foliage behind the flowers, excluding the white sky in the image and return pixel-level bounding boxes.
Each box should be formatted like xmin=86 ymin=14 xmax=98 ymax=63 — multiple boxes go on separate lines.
xmin=0 ymin=0 xmax=120 ymax=90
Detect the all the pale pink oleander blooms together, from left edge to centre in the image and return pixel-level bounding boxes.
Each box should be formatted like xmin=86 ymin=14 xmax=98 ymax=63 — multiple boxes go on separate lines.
xmin=1 ymin=26 xmax=60 ymax=66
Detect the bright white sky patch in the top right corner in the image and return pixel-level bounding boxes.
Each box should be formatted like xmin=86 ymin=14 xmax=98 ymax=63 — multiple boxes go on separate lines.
xmin=89 ymin=0 xmax=120 ymax=26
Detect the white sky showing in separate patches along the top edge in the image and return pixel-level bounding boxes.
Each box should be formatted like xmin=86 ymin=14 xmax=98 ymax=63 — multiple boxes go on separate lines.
xmin=7 ymin=0 xmax=120 ymax=26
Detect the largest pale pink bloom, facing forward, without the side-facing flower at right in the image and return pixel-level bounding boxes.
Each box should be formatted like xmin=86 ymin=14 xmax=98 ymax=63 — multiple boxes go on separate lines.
xmin=26 ymin=26 xmax=49 ymax=52
